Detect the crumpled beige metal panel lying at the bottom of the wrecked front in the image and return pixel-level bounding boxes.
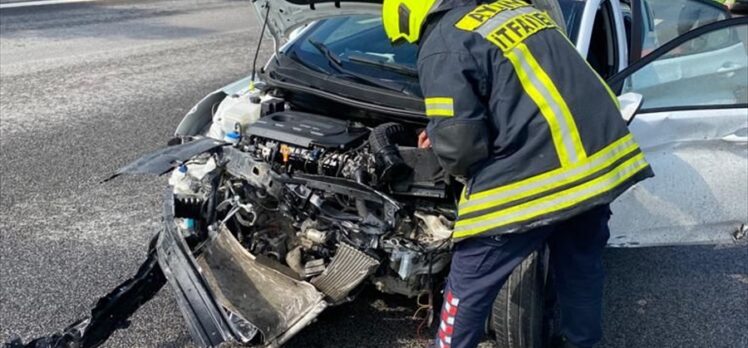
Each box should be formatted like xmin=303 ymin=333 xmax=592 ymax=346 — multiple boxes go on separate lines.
xmin=198 ymin=226 xmax=324 ymax=343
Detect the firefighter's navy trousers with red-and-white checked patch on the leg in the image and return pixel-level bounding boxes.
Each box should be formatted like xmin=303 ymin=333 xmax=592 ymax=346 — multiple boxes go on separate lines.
xmin=434 ymin=205 xmax=610 ymax=348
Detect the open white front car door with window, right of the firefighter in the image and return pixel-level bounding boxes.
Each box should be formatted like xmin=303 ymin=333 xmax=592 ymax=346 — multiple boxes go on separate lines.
xmin=609 ymin=17 xmax=748 ymax=246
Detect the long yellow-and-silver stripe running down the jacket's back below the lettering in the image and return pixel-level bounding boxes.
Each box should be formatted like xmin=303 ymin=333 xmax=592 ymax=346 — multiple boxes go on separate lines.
xmin=506 ymin=44 xmax=587 ymax=167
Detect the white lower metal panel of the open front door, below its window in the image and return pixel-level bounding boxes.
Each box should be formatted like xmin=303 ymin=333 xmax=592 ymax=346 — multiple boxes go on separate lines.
xmin=609 ymin=109 xmax=748 ymax=247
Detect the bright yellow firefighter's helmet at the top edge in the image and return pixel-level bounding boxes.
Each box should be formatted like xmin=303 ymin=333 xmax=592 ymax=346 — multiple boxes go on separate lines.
xmin=382 ymin=0 xmax=437 ymax=43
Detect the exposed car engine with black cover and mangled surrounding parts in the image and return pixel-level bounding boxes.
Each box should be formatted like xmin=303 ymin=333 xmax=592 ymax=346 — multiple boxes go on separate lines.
xmin=170 ymin=92 xmax=456 ymax=303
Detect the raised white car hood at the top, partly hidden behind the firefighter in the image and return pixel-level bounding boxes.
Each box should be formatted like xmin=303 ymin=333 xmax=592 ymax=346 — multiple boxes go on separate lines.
xmin=252 ymin=0 xmax=566 ymax=42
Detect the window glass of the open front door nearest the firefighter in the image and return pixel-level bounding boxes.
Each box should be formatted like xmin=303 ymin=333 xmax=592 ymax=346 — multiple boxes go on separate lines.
xmin=612 ymin=19 xmax=748 ymax=109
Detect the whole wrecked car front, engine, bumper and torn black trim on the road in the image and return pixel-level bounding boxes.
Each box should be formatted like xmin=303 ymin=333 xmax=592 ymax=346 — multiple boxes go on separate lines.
xmin=11 ymin=91 xmax=461 ymax=347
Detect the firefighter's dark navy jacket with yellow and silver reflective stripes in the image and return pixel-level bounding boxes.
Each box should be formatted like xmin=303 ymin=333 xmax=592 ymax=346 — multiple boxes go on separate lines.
xmin=418 ymin=0 xmax=654 ymax=240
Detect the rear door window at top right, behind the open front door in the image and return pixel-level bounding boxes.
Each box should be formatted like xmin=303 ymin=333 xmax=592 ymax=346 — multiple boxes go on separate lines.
xmin=635 ymin=0 xmax=730 ymax=58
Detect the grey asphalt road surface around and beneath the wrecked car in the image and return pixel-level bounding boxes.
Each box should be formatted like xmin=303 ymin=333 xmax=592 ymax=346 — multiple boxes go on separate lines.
xmin=0 ymin=0 xmax=748 ymax=347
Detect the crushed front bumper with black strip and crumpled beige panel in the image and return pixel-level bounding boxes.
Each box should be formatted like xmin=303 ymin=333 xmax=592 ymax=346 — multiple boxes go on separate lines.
xmin=156 ymin=190 xmax=328 ymax=347
